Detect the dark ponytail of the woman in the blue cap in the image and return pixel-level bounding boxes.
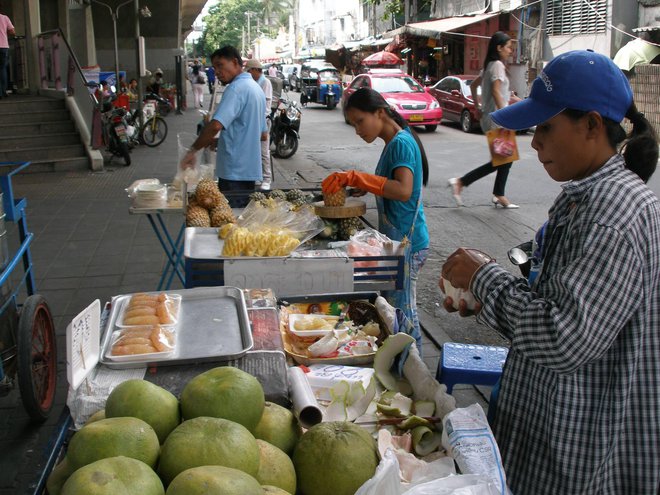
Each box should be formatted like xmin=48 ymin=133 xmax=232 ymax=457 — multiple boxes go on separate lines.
xmin=621 ymin=102 xmax=658 ymax=182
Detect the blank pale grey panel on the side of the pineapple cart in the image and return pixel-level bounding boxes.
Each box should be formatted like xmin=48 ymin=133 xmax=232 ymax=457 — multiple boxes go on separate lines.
xmin=224 ymin=258 xmax=353 ymax=297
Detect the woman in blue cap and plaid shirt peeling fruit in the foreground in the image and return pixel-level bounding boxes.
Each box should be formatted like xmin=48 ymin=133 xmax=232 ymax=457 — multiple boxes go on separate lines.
xmin=442 ymin=50 xmax=660 ymax=495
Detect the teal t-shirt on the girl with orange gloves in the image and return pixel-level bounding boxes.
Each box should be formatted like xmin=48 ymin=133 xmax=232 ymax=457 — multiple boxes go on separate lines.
xmin=376 ymin=129 xmax=429 ymax=252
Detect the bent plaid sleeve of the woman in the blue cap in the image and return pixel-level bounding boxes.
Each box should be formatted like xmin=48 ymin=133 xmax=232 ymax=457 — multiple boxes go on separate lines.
xmin=473 ymin=225 xmax=643 ymax=373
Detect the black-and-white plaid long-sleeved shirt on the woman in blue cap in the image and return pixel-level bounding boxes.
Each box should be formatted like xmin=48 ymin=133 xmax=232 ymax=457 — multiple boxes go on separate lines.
xmin=472 ymin=155 xmax=660 ymax=495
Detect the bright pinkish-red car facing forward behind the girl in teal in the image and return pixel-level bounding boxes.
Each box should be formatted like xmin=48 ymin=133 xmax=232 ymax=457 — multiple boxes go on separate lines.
xmin=342 ymin=69 xmax=442 ymax=132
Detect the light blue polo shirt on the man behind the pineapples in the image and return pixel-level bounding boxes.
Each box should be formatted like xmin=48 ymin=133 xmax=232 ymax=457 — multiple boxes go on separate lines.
xmin=213 ymin=72 xmax=268 ymax=181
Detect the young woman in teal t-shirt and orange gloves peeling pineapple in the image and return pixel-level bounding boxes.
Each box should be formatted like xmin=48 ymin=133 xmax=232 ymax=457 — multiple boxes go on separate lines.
xmin=322 ymin=88 xmax=429 ymax=351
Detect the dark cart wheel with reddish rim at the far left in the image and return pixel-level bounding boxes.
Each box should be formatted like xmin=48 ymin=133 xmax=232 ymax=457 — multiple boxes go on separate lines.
xmin=17 ymin=295 xmax=57 ymax=421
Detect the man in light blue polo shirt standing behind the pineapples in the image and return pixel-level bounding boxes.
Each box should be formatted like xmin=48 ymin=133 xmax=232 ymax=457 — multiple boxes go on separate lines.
xmin=181 ymin=46 xmax=268 ymax=207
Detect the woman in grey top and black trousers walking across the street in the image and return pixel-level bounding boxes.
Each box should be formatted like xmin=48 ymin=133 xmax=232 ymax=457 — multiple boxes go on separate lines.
xmin=448 ymin=31 xmax=518 ymax=208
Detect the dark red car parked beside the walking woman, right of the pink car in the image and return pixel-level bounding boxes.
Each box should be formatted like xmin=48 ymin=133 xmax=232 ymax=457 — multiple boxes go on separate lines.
xmin=426 ymin=74 xmax=522 ymax=132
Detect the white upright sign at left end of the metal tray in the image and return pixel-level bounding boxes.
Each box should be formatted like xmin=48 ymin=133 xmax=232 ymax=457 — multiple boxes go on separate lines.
xmin=66 ymin=299 xmax=101 ymax=390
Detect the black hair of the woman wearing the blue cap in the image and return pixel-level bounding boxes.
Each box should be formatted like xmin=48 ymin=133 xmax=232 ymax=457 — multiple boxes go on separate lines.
xmin=562 ymin=102 xmax=658 ymax=182
